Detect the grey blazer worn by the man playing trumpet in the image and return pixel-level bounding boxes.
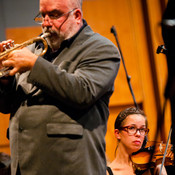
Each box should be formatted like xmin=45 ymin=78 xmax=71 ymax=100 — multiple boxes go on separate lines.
xmin=0 ymin=26 xmax=120 ymax=175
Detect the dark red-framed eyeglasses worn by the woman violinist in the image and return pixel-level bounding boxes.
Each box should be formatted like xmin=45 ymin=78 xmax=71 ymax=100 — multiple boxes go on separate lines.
xmin=119 ymin=126 xmax=149 ymax=136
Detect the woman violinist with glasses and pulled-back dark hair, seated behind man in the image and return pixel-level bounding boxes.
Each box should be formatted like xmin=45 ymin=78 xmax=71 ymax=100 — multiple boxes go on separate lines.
xmin=107 ymin=107 xmax=167 ymax=175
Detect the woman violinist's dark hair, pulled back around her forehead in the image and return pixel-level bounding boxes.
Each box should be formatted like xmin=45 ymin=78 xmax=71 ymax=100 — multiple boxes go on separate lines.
xmin=114 ymin=107 xmax=148 ymax=129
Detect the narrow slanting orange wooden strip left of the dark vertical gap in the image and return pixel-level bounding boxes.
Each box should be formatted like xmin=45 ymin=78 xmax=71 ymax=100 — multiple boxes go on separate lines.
xmin=130 ymin=0 xmax=157 ymax=140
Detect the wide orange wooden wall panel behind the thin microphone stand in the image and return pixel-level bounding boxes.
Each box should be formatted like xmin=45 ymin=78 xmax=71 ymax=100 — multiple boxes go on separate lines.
xmin=83 ymin=0 xmax=143 ymax=106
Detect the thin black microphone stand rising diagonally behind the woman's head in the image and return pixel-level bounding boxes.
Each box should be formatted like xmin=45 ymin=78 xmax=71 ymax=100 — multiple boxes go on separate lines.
xmin=111 ymin=26 xmax=139 ymax=108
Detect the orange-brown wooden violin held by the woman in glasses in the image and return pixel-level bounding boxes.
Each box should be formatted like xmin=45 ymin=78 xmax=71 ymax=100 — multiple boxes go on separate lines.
xmin=130 ymin=142 xmax=174 ymax=170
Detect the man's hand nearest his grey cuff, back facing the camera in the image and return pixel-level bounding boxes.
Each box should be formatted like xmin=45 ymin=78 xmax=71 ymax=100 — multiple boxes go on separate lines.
xmin=2 ymin=48 xmax=38 ymax=76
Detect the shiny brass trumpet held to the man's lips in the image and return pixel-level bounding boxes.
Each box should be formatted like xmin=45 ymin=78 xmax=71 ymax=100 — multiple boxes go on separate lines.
xmin=0 ymin=33 xmax=50 ymax=78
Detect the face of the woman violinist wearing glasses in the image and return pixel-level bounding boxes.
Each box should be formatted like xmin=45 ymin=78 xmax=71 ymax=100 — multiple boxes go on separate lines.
xmin=115 ymin=114 xmax=146 ymax=154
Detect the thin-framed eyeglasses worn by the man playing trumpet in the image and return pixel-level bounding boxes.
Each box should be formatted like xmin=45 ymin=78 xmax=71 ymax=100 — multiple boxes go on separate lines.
xmin=34 ymin=8 xmax=77 ymax=24
